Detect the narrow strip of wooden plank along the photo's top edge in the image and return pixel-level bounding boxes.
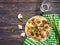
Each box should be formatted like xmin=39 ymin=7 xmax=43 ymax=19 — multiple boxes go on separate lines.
xmin=0 ymin=0 xmax=60 ymax=3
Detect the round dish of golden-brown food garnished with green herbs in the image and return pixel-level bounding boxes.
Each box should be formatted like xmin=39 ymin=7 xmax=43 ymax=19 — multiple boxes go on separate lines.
xmin=25 ymin=16 xmax=51 ymax=41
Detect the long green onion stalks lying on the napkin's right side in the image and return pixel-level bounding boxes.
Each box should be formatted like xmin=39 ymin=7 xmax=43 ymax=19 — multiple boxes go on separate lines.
xmin=48 ymin=15 xmax=60 ymax=45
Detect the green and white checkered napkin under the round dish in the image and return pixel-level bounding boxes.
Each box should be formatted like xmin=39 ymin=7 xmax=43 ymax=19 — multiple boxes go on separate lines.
xmin=23 ymin=14 xmax=59 ymax=45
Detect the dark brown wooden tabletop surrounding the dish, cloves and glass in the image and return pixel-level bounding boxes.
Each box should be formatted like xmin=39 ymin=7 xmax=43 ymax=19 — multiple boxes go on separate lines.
xmin=0 ymin=0 xmax=60 ymax=45
